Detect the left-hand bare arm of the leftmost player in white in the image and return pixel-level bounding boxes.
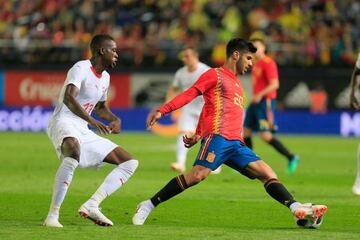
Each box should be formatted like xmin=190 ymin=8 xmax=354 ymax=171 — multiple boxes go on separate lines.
xmin=63 ymin=84 xmax=110 ymax=134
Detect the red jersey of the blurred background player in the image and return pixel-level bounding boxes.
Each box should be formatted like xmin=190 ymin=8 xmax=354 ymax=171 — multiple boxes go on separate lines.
xmin=252 ymin=56 xmax=279 ymax=99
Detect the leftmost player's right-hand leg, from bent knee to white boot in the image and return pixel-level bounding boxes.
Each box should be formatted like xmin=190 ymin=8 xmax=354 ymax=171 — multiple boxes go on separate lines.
xmin=79 ymin=147 xmax=138 ymax=226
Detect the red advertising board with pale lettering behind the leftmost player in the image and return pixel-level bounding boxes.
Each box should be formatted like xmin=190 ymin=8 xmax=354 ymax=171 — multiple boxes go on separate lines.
xmin=4 ymin=71 xmax=130 ymax=107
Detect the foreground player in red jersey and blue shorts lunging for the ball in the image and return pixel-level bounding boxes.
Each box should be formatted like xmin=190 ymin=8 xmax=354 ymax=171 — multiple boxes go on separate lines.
xmin=132 ymin=38 xmax=327 ymax=225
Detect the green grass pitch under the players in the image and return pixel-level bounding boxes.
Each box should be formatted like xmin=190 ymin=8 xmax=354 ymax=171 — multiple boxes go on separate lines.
xmin=0 ymin=133 xmax=360 ymax=240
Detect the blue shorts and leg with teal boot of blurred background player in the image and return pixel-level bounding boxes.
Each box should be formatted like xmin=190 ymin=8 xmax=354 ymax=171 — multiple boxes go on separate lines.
xmin=257 ymin=100 xmax=300 ymax=174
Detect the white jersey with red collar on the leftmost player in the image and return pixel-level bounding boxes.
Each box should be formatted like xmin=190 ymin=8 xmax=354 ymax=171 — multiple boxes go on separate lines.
xmin=50 ymin=60 xmax=110 ymax=127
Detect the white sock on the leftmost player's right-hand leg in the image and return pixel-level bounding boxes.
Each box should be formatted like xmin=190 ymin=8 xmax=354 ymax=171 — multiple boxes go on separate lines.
xmin=85 ymin=159 xmax=139 ymax=207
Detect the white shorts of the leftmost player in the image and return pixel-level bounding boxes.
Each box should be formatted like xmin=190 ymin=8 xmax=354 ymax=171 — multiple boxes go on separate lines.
xmin=47 ymin=119 xmax=118 ymax=168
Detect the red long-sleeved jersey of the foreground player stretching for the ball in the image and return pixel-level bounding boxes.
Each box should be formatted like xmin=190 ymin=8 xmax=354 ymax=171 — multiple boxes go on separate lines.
xmin=159 ymin=67 xmax=244 ymax=141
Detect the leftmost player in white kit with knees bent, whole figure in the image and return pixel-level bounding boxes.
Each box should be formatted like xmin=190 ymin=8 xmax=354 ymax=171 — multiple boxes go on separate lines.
xmin=44 ymin=35 xmax=138 ymax=227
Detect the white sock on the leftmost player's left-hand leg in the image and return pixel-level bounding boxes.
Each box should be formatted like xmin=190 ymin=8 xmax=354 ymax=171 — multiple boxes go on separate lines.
xmin=48 ymin=157 xmax=79 ymax=219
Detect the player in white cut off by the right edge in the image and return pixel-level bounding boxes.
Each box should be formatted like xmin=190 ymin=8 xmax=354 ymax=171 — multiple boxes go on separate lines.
xmin=350 ymin=52 xmax=360 ymax=196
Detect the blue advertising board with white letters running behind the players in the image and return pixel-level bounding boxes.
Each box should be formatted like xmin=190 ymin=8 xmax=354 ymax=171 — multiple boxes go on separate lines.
xmin=0 ymin=106 xmax=360 ymax=137
